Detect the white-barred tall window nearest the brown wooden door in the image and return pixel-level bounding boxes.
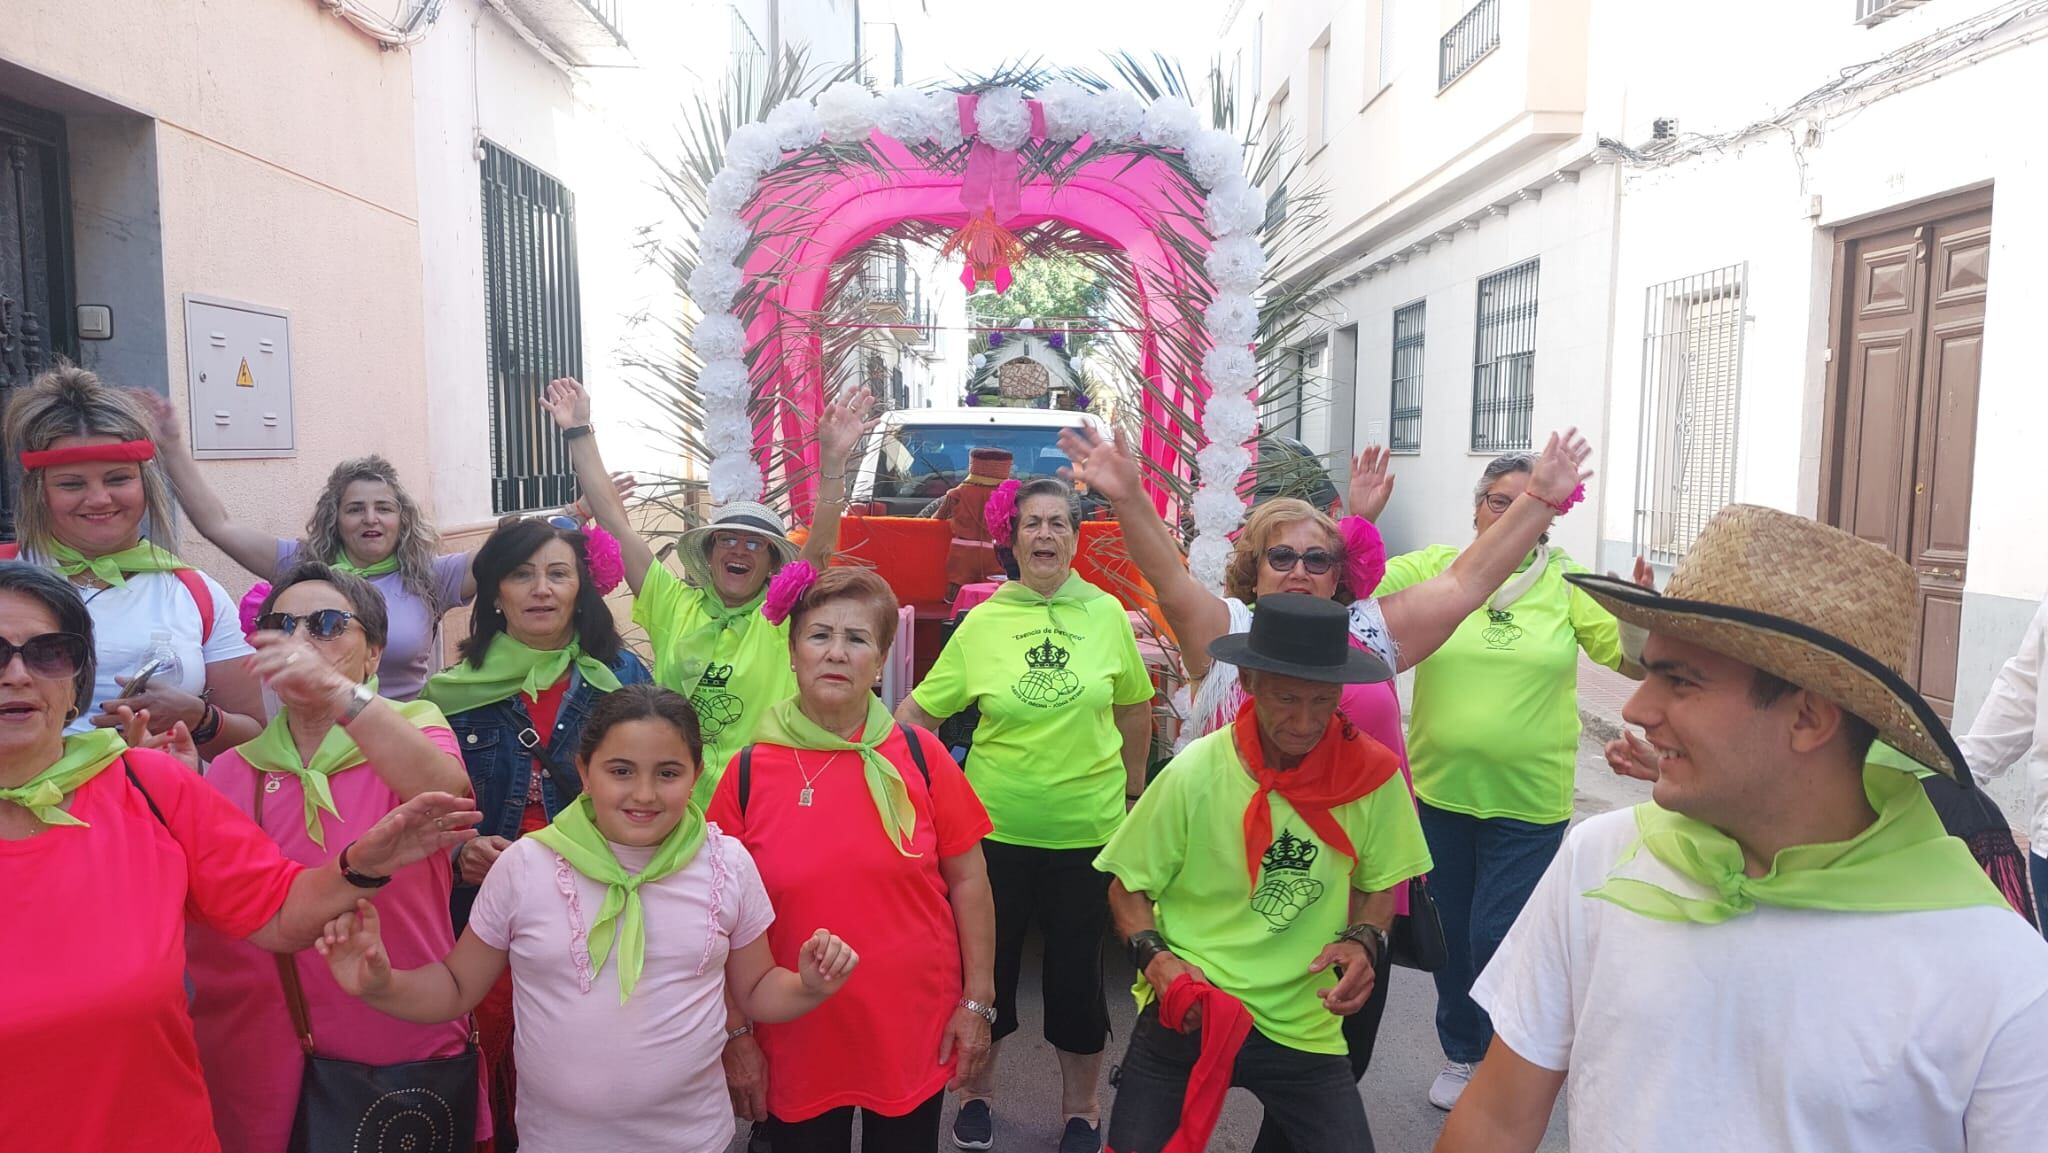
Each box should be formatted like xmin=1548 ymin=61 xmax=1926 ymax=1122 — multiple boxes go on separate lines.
xmin=1634 ymin=264 xmax=1749 ymax=565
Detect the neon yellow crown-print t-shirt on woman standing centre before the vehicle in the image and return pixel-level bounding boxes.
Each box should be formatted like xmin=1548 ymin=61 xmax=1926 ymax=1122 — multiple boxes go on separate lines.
xmin=911 ymin=575 xmax=1153 ymax=848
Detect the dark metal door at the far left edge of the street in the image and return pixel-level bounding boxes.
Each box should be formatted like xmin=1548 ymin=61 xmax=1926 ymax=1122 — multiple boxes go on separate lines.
xmin=0 ymin=100 xmax=78 ymax=539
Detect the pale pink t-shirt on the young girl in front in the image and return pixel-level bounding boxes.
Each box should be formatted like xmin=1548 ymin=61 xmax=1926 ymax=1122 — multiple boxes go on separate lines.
xmin=469 ymin=825 xmax=774 ymax=1153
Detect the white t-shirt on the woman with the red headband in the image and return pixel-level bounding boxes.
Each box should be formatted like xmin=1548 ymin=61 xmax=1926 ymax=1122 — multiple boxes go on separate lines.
xmin=63 ymin=573 xmax=256 ymax=733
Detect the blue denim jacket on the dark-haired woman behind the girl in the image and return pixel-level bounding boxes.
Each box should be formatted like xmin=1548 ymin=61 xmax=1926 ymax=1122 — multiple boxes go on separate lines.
xmin=449 ymin=649 xmax=653 ymax=932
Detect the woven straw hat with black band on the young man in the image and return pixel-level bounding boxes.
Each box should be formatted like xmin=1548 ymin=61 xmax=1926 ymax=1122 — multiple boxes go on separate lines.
xmin=1565 ymin=504 xmax=1970 ymax=782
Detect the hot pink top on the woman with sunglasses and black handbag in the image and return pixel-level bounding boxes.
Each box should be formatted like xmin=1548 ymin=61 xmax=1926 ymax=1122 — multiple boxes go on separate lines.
xmin=184 ymin=727 xmax=492 ymax=1153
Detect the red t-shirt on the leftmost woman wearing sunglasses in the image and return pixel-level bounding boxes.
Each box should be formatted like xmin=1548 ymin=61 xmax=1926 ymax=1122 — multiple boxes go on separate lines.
xmin=0 ymin=750 xmax=299 ymax=1153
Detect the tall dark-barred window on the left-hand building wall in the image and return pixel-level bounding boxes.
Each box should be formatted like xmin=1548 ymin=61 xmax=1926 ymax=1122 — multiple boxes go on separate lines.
xmin=481 ymin=141 xmax=584 ymax=512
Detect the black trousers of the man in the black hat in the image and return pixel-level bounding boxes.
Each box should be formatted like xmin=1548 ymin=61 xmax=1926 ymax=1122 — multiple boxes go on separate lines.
xmin=1110 ymin=1003 xmax=1372 ymax=1153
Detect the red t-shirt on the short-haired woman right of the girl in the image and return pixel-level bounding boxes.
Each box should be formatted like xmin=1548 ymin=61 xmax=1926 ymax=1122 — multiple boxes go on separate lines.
xmin=709 ymin=729 xmax=993 ymax=1120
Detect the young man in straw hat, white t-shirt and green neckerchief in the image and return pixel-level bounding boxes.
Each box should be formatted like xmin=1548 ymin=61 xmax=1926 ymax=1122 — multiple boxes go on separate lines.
xmin=1436 ymin=506 xmax=2048 ymax=1153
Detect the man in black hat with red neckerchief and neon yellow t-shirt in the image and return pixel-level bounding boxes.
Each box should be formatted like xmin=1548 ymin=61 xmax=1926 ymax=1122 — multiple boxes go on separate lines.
xmin=1096 ymin=594 xmax=1430 ymax=1153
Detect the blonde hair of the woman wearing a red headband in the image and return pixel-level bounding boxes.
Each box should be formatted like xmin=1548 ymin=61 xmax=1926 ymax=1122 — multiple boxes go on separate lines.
xmin=6 ymin=358 xmax=178 ymax=555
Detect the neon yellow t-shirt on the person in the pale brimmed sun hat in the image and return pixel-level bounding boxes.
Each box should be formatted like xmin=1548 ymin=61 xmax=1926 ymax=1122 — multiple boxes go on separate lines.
xmin=633 ymin=561 xmax=797 ymax=805
